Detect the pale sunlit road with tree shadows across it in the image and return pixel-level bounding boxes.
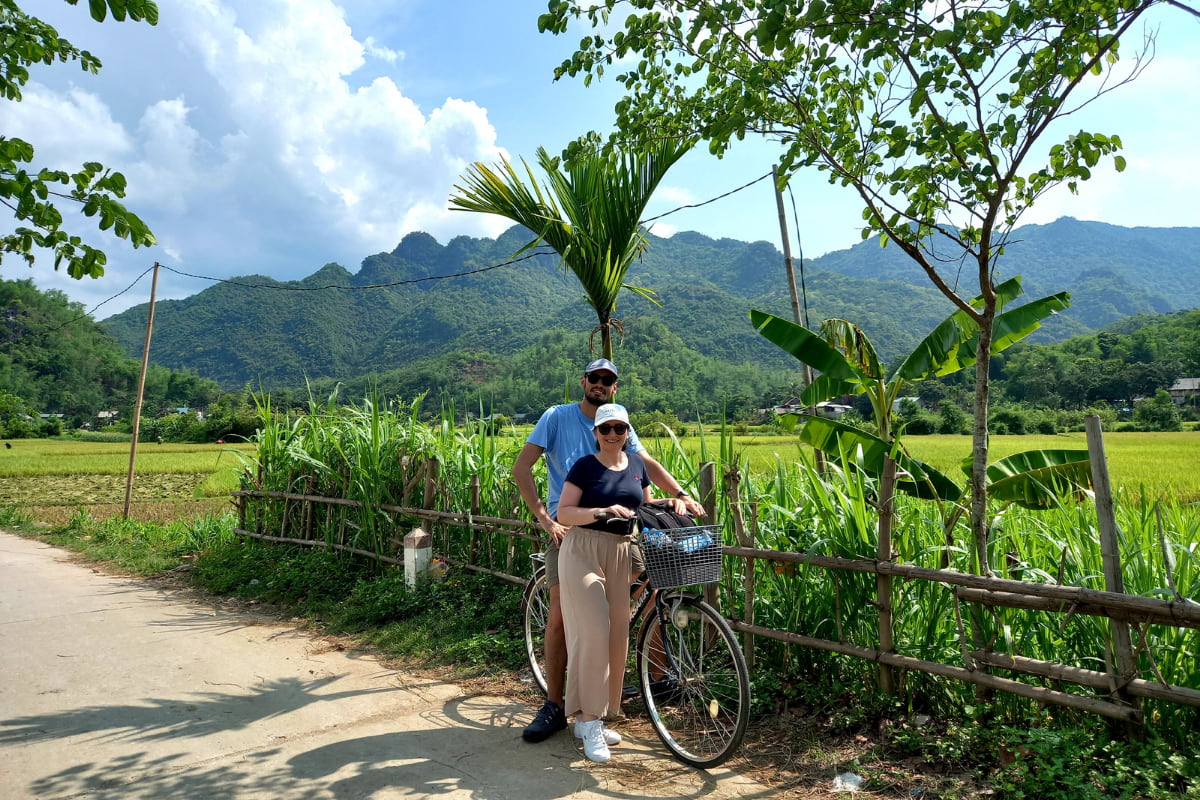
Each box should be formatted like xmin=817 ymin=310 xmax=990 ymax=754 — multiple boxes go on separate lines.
xmin=0 ymin=533 xmax=770 ymax=800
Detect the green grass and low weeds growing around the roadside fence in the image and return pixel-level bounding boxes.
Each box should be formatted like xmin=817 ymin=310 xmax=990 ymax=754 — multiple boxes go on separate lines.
xmin=0 ymin=399 xmax=1200 ymax=800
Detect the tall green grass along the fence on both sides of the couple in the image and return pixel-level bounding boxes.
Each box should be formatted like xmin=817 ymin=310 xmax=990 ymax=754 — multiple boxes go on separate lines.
xmin=236 ymin=397 xmax=1200 ymax=748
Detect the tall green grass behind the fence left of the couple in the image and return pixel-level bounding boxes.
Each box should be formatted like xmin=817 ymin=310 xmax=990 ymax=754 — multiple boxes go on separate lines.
xmin=236 ymin=395 xmax=528 ymax=564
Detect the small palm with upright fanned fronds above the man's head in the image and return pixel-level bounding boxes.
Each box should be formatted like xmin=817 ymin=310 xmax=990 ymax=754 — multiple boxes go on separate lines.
xmin=450 ymin=140 xmax=694 ymax=359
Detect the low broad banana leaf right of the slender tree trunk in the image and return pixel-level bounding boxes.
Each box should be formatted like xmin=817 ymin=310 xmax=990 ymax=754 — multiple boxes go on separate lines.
xmin=961 ymin=450 xmax=1092 ymax=510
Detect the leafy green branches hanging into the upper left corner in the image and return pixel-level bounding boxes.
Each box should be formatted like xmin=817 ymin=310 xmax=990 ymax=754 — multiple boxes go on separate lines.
xmin=0 ymin=0 xmax=158 ymax=278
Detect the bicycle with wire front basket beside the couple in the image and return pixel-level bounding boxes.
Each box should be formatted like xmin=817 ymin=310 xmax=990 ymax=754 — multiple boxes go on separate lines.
xmin=521 ymin=525 xmax=750 ymax=769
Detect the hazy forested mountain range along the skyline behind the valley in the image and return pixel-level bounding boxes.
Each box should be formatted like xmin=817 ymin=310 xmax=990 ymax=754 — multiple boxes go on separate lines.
xmin=104 ymin=218 xmax=1200 ymax=389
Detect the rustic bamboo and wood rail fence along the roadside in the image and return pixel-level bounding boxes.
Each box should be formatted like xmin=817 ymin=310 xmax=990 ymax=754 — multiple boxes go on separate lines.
xmin=234 ymin=438 xmax=1200 ymax=723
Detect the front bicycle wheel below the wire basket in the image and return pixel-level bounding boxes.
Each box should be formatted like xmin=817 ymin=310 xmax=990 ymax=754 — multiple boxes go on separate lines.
xmin=637 ymin=594 xmax=750 ymax=769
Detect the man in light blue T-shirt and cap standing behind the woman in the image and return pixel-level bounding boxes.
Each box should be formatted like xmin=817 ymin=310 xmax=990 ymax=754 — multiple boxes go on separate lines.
xmin=512 ymin=359 xmax=704 ymax=741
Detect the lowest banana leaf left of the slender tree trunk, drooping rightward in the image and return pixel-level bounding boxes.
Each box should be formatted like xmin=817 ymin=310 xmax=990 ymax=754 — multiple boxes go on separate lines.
xmin=799 ymin=416 xmax=962 ymax=501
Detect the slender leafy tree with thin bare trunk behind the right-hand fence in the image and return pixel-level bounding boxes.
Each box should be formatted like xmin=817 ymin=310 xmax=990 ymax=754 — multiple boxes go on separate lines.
xmin=539 ymin=0 xmax=1181 ymax=569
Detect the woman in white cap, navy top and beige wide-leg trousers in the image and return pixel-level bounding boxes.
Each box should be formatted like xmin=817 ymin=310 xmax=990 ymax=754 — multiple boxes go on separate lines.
xmin=549 ymin=403 xmax=676 ymax=762
